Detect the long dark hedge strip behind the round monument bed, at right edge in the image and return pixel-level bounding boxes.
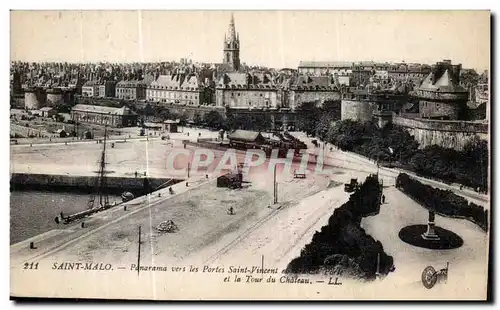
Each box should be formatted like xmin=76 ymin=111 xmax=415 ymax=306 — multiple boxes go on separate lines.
xmin=396 ymin=173 xmax=488 ymax=231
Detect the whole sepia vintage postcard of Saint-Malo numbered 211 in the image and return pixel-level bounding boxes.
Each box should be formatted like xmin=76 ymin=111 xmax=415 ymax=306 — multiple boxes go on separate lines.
xmin=10 ymin=10 xmax=492 ymax=300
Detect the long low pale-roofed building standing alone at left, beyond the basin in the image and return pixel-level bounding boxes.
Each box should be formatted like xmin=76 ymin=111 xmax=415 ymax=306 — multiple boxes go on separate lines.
xmin=71 ymin=104 xmax=137 ymax=127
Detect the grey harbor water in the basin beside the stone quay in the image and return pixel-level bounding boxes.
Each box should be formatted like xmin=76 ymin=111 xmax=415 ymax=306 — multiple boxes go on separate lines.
xmin=10 ymin=191 xmax=121 ymax=244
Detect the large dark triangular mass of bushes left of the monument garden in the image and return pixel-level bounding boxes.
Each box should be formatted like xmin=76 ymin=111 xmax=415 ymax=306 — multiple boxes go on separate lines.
xmin=287 ymin=176 xmax=393 ymax=279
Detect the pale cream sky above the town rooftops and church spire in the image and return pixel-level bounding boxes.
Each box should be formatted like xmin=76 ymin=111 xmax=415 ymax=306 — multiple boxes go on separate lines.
xmin=10 ymin=10 xmax=490 ymax=71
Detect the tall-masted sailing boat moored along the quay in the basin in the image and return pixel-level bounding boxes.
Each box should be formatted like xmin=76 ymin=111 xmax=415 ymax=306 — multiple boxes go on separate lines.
xmin=55 ymin=126 xmax=116 ymax=224
